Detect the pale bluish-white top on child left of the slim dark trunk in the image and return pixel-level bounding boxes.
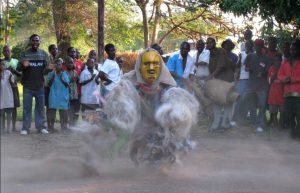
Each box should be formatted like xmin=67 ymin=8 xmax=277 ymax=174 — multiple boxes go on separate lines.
xmin=79 ymin=68 xmax=100 ymax=104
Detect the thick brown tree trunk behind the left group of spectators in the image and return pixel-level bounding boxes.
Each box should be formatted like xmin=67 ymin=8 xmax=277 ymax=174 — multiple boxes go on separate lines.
xmin=52 ymin=0 xmax=71 ymax=58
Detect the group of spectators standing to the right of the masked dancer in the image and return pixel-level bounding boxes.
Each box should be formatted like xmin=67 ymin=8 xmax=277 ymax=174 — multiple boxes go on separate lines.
xmin=167 ymin=30 xmax=300 ymax=137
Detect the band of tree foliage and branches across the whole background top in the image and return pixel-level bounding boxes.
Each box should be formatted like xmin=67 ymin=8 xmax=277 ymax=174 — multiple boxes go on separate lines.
xmin=0 ymin=0 xmax=300 ymax=53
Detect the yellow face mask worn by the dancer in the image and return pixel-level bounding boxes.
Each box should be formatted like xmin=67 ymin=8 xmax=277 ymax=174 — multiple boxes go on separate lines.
xmin=140 ymin=51 xmax=161 ymax=84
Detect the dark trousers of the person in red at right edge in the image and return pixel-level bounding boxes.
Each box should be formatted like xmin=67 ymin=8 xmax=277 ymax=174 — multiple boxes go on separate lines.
xmin=284 ymin=96 xmax=300 ymax=138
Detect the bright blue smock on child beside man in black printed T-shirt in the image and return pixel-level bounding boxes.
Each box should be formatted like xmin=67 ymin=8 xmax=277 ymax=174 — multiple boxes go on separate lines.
xmin=48 ymin=71 xmax=70 ymax=110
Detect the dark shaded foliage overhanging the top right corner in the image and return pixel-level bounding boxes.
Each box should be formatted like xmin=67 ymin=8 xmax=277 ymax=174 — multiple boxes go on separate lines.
xmin=206 ymin=0 xmax=300 ymax=44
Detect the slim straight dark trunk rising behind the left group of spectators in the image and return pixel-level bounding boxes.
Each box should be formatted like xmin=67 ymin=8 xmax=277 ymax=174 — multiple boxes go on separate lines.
xmin=98 ymin=0 xmax=105 ymax=63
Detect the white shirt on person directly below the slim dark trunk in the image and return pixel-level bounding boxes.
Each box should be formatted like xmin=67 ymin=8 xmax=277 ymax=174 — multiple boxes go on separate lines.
xmin=100 ymin=59 xmax=121 ymax=91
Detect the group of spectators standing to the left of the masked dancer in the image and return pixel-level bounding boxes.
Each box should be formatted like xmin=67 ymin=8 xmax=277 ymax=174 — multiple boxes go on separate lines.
xmin=0 ymin=34 xmax=122 ymax=135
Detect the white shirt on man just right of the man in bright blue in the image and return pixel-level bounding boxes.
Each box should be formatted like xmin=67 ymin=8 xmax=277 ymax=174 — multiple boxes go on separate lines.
xmin=193 ymin=49 xmax=210 ymax=77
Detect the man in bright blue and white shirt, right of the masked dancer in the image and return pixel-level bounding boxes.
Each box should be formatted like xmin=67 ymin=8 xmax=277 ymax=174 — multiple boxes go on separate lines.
xmin=167 ymin=42 xmax=194 ymax=87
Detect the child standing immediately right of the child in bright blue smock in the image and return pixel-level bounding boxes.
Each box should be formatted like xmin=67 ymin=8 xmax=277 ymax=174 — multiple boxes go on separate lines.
xmin=65 ymin=57 xmax=80 ymax=126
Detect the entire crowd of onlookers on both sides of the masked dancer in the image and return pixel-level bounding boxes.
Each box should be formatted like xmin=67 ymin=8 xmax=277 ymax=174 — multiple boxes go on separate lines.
xmin=0 ymin=30 xmax=300 ymax=137
